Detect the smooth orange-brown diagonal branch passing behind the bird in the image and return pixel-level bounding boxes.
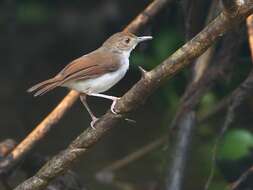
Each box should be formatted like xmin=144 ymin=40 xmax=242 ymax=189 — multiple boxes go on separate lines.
xmin=0 ymin=0 xmax=171 ymax=177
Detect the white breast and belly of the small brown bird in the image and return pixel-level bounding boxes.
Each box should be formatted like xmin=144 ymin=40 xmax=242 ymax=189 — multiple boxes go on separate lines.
xmin=67 ymin=56 xmax=129 ymax=94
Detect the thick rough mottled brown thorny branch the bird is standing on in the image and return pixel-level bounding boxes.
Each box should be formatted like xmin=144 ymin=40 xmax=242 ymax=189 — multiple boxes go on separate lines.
xmin=16 ymin=0 xmax=253 ymax=190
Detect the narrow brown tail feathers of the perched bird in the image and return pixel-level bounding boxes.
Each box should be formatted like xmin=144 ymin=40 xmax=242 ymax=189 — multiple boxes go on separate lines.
xmin=27 ymin=78 xmax=60 ymax=97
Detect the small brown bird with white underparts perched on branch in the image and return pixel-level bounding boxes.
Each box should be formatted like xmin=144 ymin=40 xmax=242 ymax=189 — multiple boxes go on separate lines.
xmin=27 ymin=31 xmax=152 ymax=129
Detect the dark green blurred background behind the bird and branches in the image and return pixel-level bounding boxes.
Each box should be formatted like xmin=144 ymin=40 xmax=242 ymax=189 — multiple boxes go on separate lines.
xmin=0 ymin=0 xmax=253 ymax=190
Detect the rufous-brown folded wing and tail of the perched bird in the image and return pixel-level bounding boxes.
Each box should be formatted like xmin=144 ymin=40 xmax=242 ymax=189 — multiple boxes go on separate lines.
xmin=28 ymin=50 xmax=120 ymax=96
